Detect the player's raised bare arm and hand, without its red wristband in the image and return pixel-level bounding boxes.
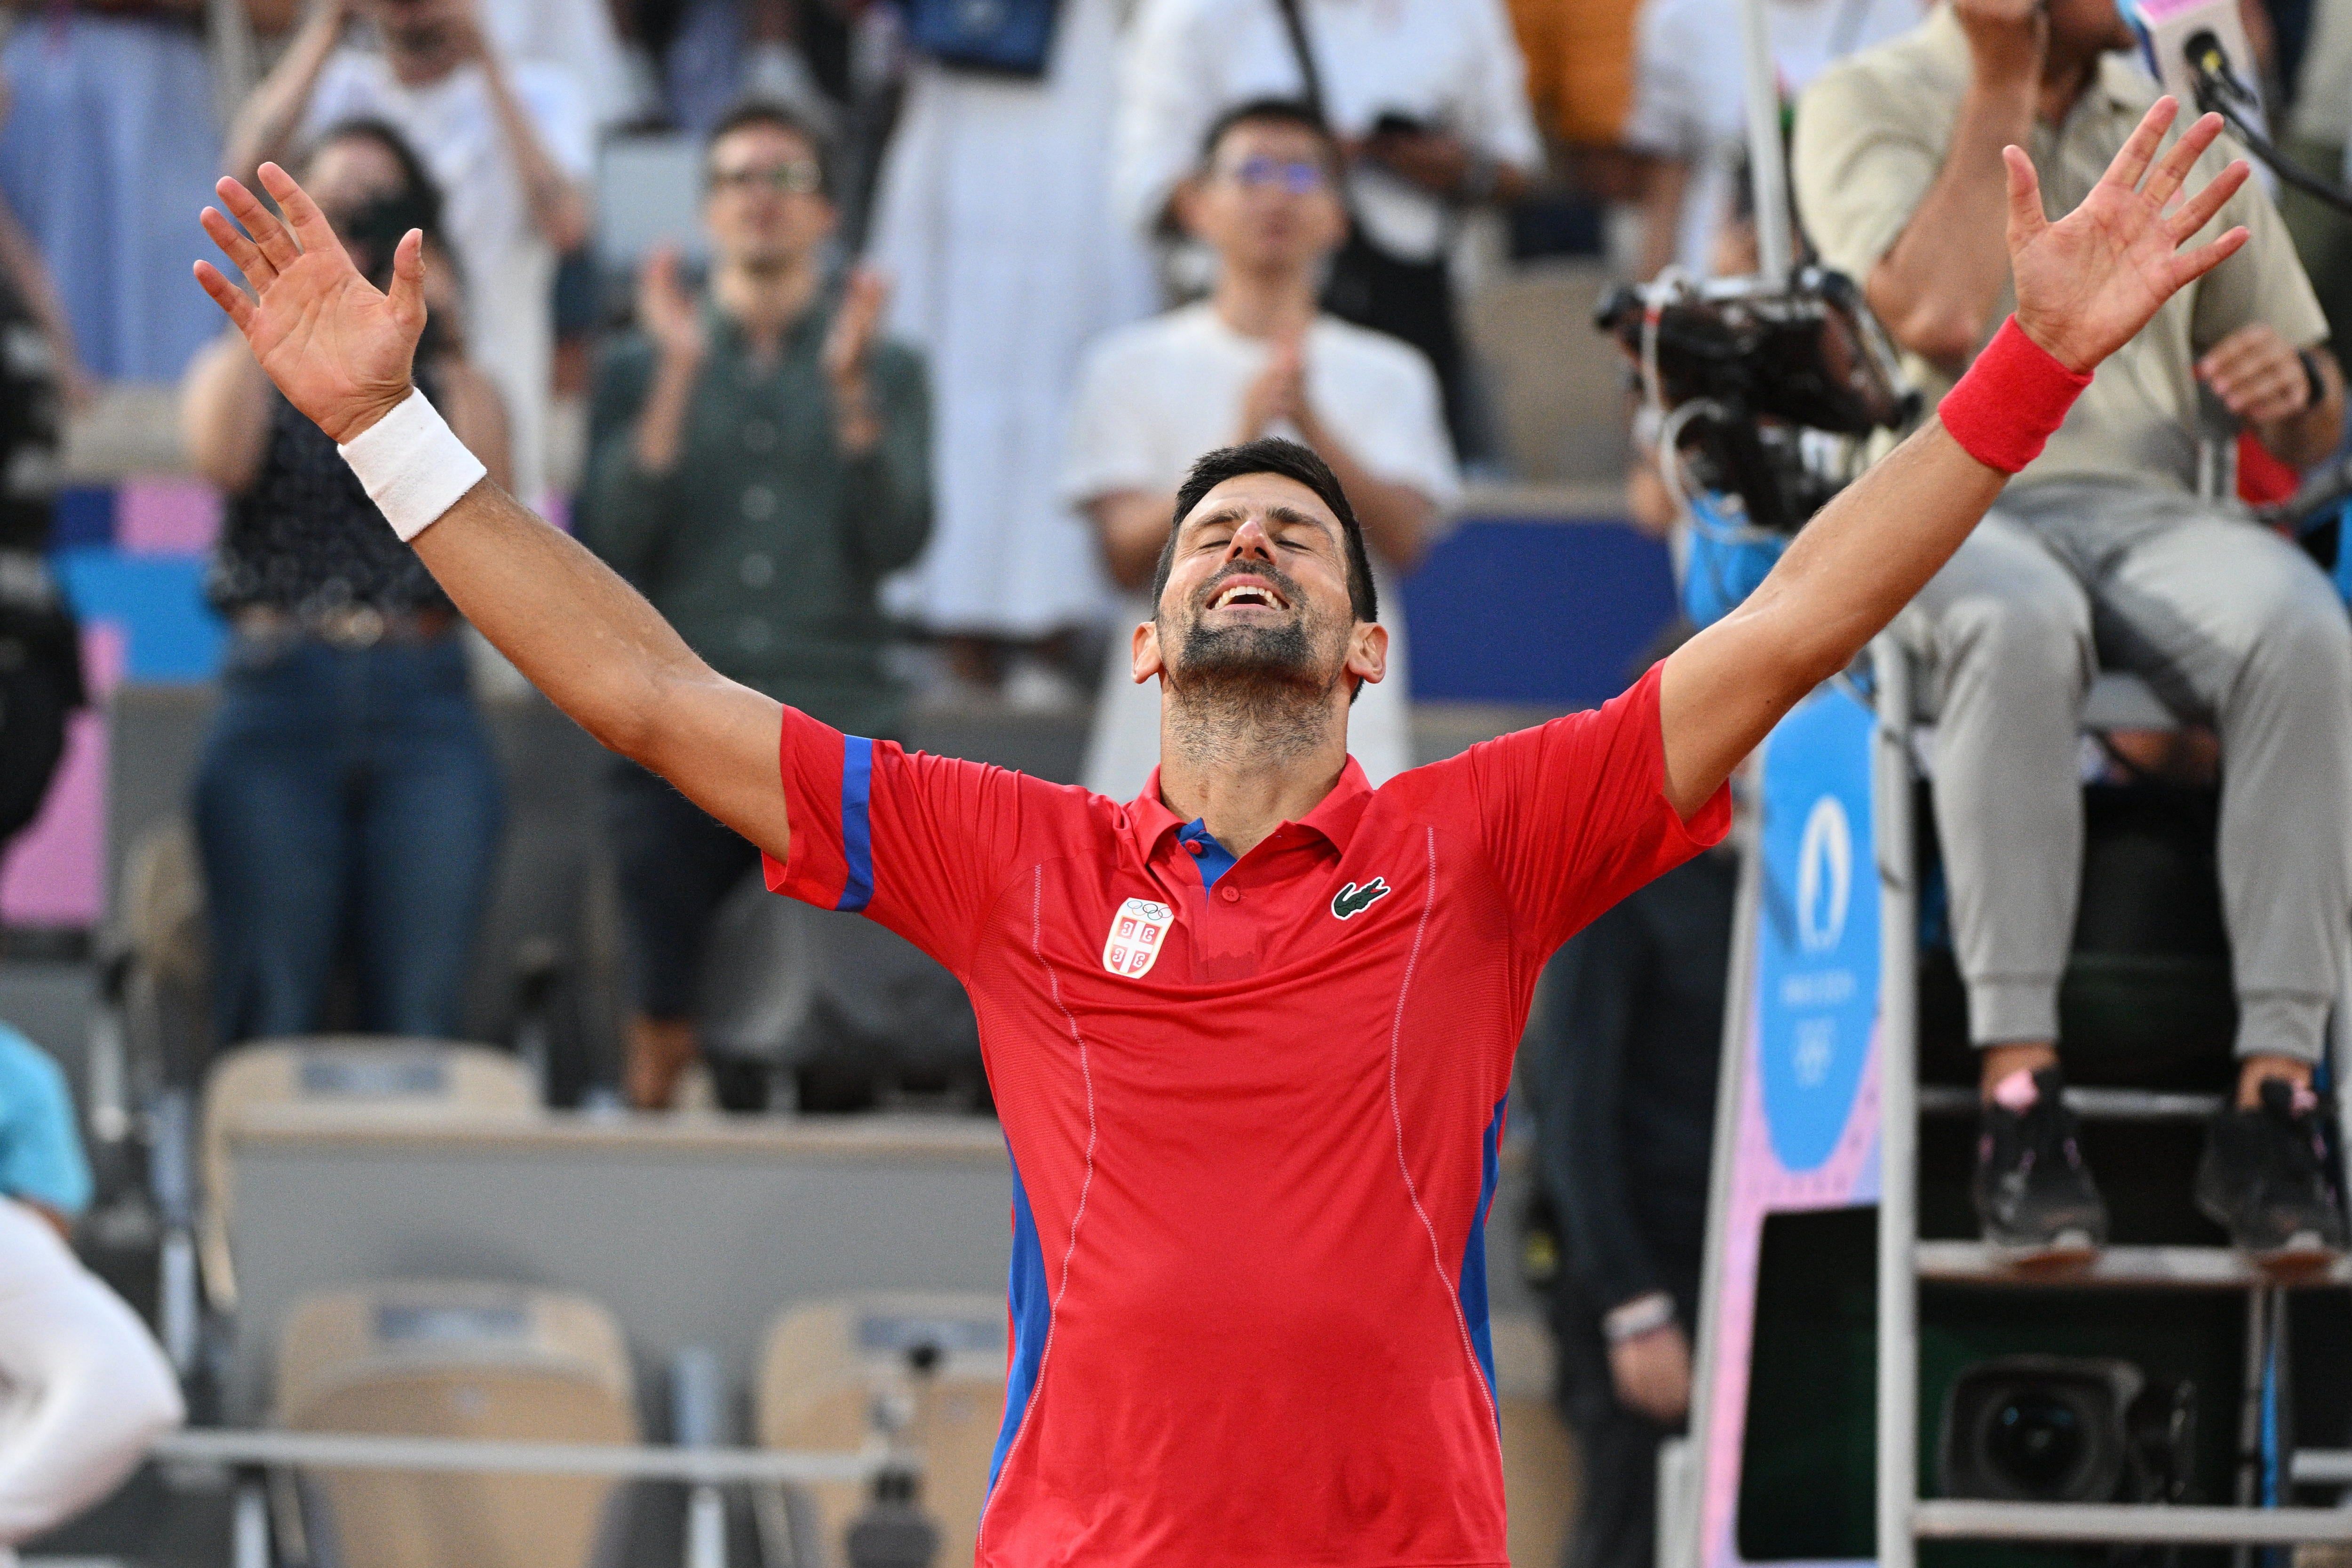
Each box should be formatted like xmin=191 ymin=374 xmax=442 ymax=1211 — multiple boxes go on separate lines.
xmin=1658 ymin=99 xmax=2246 ymax=816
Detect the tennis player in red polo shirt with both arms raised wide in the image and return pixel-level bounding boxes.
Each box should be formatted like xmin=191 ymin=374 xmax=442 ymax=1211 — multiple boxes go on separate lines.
xmin=195 ymin=99 xmax=2246 ymax=1568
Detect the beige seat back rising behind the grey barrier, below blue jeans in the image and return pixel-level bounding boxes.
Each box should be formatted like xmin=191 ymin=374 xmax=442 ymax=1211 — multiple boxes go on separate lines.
xmin=198 ymin=1037 xmax=539 ymax=1312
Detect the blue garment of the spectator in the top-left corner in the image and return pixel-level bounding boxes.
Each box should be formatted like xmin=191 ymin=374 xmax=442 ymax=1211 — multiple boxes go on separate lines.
xmin=0 ymin=0 xmax=294 ymax=381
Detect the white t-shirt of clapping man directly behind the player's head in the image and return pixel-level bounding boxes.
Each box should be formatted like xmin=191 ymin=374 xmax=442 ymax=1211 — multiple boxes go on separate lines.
xmin=1061 ymin=303 xmax=1461 ymax=799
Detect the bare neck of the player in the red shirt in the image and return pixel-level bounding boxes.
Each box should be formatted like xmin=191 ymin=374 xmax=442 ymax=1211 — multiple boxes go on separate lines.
xmin=1160 ymin=693 xmax=1348 ymax=858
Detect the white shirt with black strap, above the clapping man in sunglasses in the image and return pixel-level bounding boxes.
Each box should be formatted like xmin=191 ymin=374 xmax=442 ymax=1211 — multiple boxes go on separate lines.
xmin=1110 ymin=0 xmax=1543 ymax=259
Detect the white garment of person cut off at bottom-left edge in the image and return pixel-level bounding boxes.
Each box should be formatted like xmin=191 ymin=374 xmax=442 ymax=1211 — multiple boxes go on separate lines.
xmin=0 ymin=1201 xmax=186 ymax=1547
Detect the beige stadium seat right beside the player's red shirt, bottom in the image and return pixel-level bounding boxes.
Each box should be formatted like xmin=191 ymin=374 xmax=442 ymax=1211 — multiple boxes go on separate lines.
xmin=753 ymin=1293 xmax=1004 ymax=1568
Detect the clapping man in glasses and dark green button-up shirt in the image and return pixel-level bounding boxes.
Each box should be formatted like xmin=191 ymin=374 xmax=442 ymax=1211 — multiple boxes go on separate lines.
xmin=581 ymin=103 xmax=931 ymax=1110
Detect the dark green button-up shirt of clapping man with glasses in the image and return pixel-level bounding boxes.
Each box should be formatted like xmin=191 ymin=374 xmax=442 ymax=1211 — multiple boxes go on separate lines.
xmin=579 ymin=299 xmax=931 ymax=736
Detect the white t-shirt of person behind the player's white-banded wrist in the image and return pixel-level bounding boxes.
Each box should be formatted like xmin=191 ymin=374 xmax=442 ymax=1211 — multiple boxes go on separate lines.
xmin=303 ymin=49 xmax=595 ymax=503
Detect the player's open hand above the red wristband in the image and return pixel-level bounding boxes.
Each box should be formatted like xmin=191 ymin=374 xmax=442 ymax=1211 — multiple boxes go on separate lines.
xmin=2002 ymin=99 xmax=2246 ymax=374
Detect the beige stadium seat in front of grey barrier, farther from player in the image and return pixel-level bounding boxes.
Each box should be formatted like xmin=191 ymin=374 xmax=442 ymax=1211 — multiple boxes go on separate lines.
xmin=278 ymin=1283 xmax=637 ymax=1568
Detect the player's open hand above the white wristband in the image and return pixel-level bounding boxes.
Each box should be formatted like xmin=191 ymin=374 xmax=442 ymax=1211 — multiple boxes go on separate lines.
xmin=195 ymin=162 xmax=426 ymax=442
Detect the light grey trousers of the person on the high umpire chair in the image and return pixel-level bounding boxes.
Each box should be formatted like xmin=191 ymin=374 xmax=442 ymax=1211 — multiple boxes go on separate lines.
xmin=1896 ymin=484 xmax=2352 ymax=1060
